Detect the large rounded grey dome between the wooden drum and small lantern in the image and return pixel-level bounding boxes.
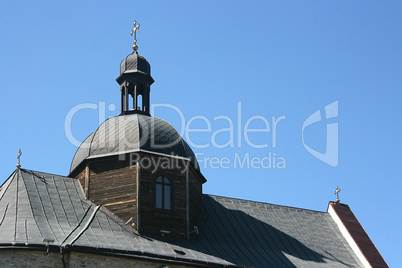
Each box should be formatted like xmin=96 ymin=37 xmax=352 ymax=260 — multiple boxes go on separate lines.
xmin=70 ymin=113 xmax=199 ymax=173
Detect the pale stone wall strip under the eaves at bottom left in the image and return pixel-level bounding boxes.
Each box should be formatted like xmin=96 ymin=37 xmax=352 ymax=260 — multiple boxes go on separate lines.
xmin=0 ymin=249 xmax=193 ymax=268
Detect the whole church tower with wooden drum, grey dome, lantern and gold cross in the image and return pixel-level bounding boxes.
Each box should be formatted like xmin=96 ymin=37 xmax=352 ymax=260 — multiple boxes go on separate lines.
xmin=69 ymin=23 xmax=206 ymax=239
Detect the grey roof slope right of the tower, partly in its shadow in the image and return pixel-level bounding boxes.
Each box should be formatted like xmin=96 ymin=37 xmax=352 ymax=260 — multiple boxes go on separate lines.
xmin=197 ymin=195 xmax=362 ymax=267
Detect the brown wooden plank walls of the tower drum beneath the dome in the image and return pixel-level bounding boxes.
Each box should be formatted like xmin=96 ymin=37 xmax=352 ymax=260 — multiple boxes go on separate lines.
xmin=71 ymin=153 xmax=204 ymax=238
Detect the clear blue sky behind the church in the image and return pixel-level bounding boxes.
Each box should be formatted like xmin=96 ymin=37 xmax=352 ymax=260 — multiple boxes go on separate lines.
xmin=0 ymin=1 xmax=402 ymax=267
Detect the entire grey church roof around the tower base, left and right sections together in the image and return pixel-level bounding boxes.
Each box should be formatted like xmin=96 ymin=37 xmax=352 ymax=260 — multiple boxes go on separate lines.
xmin=0 ymin=169 xmax=362 ymax=267
